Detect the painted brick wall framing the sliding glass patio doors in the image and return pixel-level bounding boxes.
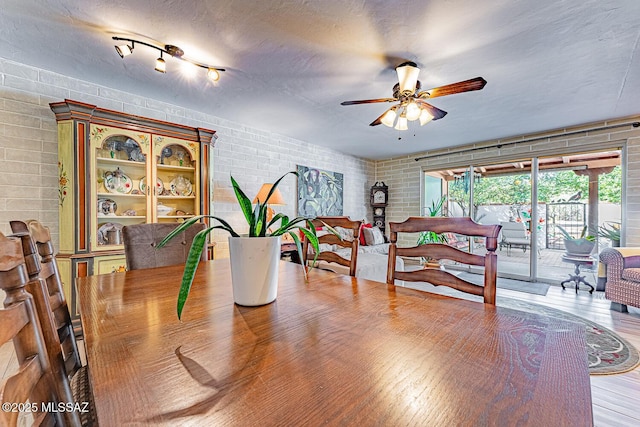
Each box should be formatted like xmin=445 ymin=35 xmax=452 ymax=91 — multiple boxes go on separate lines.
xmin=376 ymin=116 xmax=640 ymax=246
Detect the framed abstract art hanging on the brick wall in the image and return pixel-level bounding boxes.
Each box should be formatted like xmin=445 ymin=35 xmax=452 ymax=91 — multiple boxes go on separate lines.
xmin=297 ymin=165 xmax=344 ymax=217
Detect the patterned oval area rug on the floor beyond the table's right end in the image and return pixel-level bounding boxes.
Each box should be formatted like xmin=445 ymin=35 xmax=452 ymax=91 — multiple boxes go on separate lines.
xmin=496 ymin=297 xmax=640 ymax=375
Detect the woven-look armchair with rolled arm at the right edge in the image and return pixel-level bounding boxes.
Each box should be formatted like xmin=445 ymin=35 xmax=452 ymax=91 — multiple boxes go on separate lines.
xmin=600 ymin=248 xmax=640 ymax=312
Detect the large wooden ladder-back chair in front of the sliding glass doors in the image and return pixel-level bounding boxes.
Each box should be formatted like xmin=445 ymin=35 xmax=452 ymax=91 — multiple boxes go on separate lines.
xmin=387 ymin=217 xmax=501 ymax=305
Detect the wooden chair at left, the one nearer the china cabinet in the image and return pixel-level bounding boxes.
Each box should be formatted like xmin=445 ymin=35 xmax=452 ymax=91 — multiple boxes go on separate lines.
xmin=10 ymin=220 xmax=97 ymax=426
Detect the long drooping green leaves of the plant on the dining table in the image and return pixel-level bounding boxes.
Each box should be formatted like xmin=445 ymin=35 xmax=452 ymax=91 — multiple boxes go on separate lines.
xmin=158 ymin=171 xmax=322 ymax=319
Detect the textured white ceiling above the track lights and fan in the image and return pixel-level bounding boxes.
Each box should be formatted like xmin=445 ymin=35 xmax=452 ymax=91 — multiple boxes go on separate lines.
xmin=0 ymin=0 xmax=640 ymax=159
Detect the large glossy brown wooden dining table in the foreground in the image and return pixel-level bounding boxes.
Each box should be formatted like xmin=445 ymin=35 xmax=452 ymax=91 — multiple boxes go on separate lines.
xmin=76 ymin=259 xmax=593 ymax=427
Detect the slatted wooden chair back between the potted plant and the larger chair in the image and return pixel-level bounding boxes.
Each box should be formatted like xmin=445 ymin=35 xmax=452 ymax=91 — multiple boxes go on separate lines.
xmin=302 ymin=216 xmax=362 ymax=276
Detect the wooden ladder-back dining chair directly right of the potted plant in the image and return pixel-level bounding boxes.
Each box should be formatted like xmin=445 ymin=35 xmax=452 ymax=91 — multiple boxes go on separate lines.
xmin=302 ymin=216 xmax=362 ymax=276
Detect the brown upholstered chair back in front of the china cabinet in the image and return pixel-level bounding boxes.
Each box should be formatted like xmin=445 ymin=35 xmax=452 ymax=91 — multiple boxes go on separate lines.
xmin=122 ymin=222 xmax=207 ymax=270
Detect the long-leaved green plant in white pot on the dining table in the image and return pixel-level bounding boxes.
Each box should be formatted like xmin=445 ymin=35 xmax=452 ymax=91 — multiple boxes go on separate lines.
xmin=158 ymin=171 xmax=328 ymax=319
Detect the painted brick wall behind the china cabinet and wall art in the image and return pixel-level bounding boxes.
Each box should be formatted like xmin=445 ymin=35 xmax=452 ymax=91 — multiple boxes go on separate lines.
xmin=0 ymin=58 xmax=375 ymax=257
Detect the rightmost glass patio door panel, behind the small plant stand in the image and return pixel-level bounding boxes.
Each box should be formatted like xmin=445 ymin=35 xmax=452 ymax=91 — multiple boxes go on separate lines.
xmin=537 ymin=150 xmax=622 ymax=285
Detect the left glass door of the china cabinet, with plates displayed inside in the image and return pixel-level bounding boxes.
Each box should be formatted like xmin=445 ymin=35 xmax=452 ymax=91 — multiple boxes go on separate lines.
xmin=90 ymin=125 xmax=151 ymax=251
